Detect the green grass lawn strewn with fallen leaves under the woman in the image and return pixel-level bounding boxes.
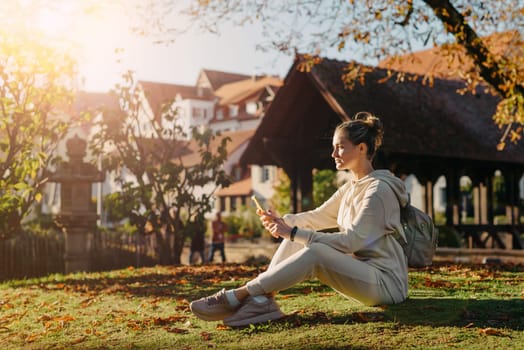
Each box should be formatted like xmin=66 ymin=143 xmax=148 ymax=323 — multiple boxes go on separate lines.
xmin=0 ymin=264 xmax=524 ymax=350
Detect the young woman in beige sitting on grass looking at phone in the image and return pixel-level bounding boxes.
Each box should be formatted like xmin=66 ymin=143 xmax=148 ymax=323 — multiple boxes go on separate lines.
xmin=190 ymin=112 xmax=408 ymax=327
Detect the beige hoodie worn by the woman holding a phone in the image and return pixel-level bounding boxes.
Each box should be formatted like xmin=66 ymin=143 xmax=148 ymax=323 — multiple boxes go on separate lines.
xmin=284 ymin=170 xmax=408 ymax=295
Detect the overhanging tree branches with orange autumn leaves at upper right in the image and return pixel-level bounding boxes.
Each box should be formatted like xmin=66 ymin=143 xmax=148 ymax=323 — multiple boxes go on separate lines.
xmin=134 ymin=0 xmax=524 ymax=150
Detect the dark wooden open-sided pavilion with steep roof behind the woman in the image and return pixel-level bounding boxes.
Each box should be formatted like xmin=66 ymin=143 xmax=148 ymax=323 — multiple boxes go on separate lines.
xmin=241 ymin=59 xmax=524 ymax=249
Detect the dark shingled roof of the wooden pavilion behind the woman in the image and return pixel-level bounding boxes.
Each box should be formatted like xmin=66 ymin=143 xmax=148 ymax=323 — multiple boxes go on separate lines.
xmin=241 ymin=59 xmax=524 ymax=165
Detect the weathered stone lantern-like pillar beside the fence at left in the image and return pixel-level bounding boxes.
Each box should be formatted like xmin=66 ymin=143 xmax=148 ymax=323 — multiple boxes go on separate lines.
xmin=49 ymin=135 xmax=104 ymax=273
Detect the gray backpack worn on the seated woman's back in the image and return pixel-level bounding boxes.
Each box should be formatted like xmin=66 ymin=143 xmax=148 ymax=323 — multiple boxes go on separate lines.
xmin=393 ymin=197 xmax=438 ymax=267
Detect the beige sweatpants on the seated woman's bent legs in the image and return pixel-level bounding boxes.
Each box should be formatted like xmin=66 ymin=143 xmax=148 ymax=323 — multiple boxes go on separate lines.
xmin=247 ymin=240 xmax=406 ymax=305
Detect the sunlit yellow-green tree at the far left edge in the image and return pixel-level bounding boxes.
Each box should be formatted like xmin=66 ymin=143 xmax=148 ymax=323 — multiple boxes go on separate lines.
xmin=0 ymin=31 xmax=77 ymax=239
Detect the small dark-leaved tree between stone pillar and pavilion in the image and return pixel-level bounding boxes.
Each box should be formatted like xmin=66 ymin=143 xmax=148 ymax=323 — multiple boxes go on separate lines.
xmin=90 ymin=72 xmax=231 ymax=264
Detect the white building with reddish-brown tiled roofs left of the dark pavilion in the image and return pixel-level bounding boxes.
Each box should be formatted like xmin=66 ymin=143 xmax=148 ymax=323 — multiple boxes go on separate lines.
xmin=139 ymin=69 xmax=282 ymax=216
